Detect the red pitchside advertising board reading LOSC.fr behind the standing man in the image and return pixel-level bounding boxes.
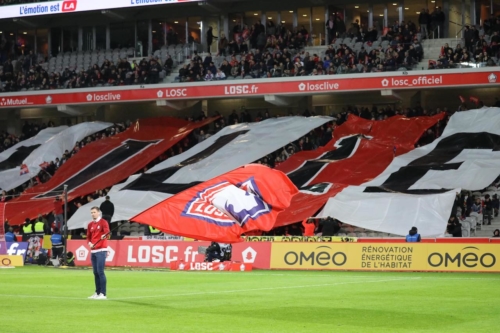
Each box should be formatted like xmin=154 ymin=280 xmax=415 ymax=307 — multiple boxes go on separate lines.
xmin=68 ymin=240 xmax=272 ymax=269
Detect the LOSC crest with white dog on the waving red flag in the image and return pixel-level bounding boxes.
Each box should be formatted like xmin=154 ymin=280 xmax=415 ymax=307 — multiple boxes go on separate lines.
xmin=182 ymin=177 xmax=271 ymax=227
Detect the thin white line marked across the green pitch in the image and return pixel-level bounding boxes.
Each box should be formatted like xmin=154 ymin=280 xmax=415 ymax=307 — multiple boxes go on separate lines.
xmin=0 ymin=277 xmax=420 ymax=301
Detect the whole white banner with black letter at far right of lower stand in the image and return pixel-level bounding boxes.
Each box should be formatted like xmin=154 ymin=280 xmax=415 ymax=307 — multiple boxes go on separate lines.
xmin=319 ymin=108 xmax=500 ymax=237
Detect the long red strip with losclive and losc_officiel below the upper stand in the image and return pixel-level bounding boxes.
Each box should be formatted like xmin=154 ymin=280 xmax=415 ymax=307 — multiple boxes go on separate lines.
xmin=0 ymin=68 xmax=500 ymax=108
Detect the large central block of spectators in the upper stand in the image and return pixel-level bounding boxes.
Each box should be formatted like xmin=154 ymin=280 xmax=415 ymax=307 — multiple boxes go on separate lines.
xmin=176 ymin=17 xmax=423 ymax=82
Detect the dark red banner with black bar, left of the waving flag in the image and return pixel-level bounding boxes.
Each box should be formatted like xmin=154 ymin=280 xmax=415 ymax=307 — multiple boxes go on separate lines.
xmin=5 ymin=117 xmax=215 ymax=225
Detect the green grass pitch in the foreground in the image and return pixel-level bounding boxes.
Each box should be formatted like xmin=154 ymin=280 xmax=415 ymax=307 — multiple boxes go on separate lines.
xmin=0 ymin=267 xmax=500 ymax=333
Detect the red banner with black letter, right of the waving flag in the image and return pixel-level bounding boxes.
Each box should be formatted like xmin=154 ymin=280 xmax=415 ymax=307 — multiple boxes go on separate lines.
xmin=275 ymin=114 xmax=445 ymax=226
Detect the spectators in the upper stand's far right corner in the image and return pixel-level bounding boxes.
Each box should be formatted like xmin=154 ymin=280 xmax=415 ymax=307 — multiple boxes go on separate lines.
xmin=429 ymin=16 xmax=500 ymax=69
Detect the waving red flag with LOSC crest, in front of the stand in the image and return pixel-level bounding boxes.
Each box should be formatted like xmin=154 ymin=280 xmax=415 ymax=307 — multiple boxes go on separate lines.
xmin=132 ymin=164 xmax=298 ymax=243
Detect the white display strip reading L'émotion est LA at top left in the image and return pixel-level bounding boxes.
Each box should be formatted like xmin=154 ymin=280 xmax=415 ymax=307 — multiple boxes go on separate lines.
xmin=0 ymin=0 xmax=201 ymax=19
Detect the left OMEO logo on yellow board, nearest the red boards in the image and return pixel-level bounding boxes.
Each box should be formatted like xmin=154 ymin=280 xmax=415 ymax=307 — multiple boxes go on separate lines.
xmin=283 ymin=245 xmax=347 ymax=267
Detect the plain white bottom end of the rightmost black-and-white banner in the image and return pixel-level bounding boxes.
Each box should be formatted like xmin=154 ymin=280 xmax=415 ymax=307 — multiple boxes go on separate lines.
xmin=318 ymin=186 xmax=460 ymax=237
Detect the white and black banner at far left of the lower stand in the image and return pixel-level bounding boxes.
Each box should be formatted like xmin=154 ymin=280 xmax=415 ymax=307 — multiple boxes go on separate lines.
xmin=0 ymin=122 xmax=113 ymax=191
